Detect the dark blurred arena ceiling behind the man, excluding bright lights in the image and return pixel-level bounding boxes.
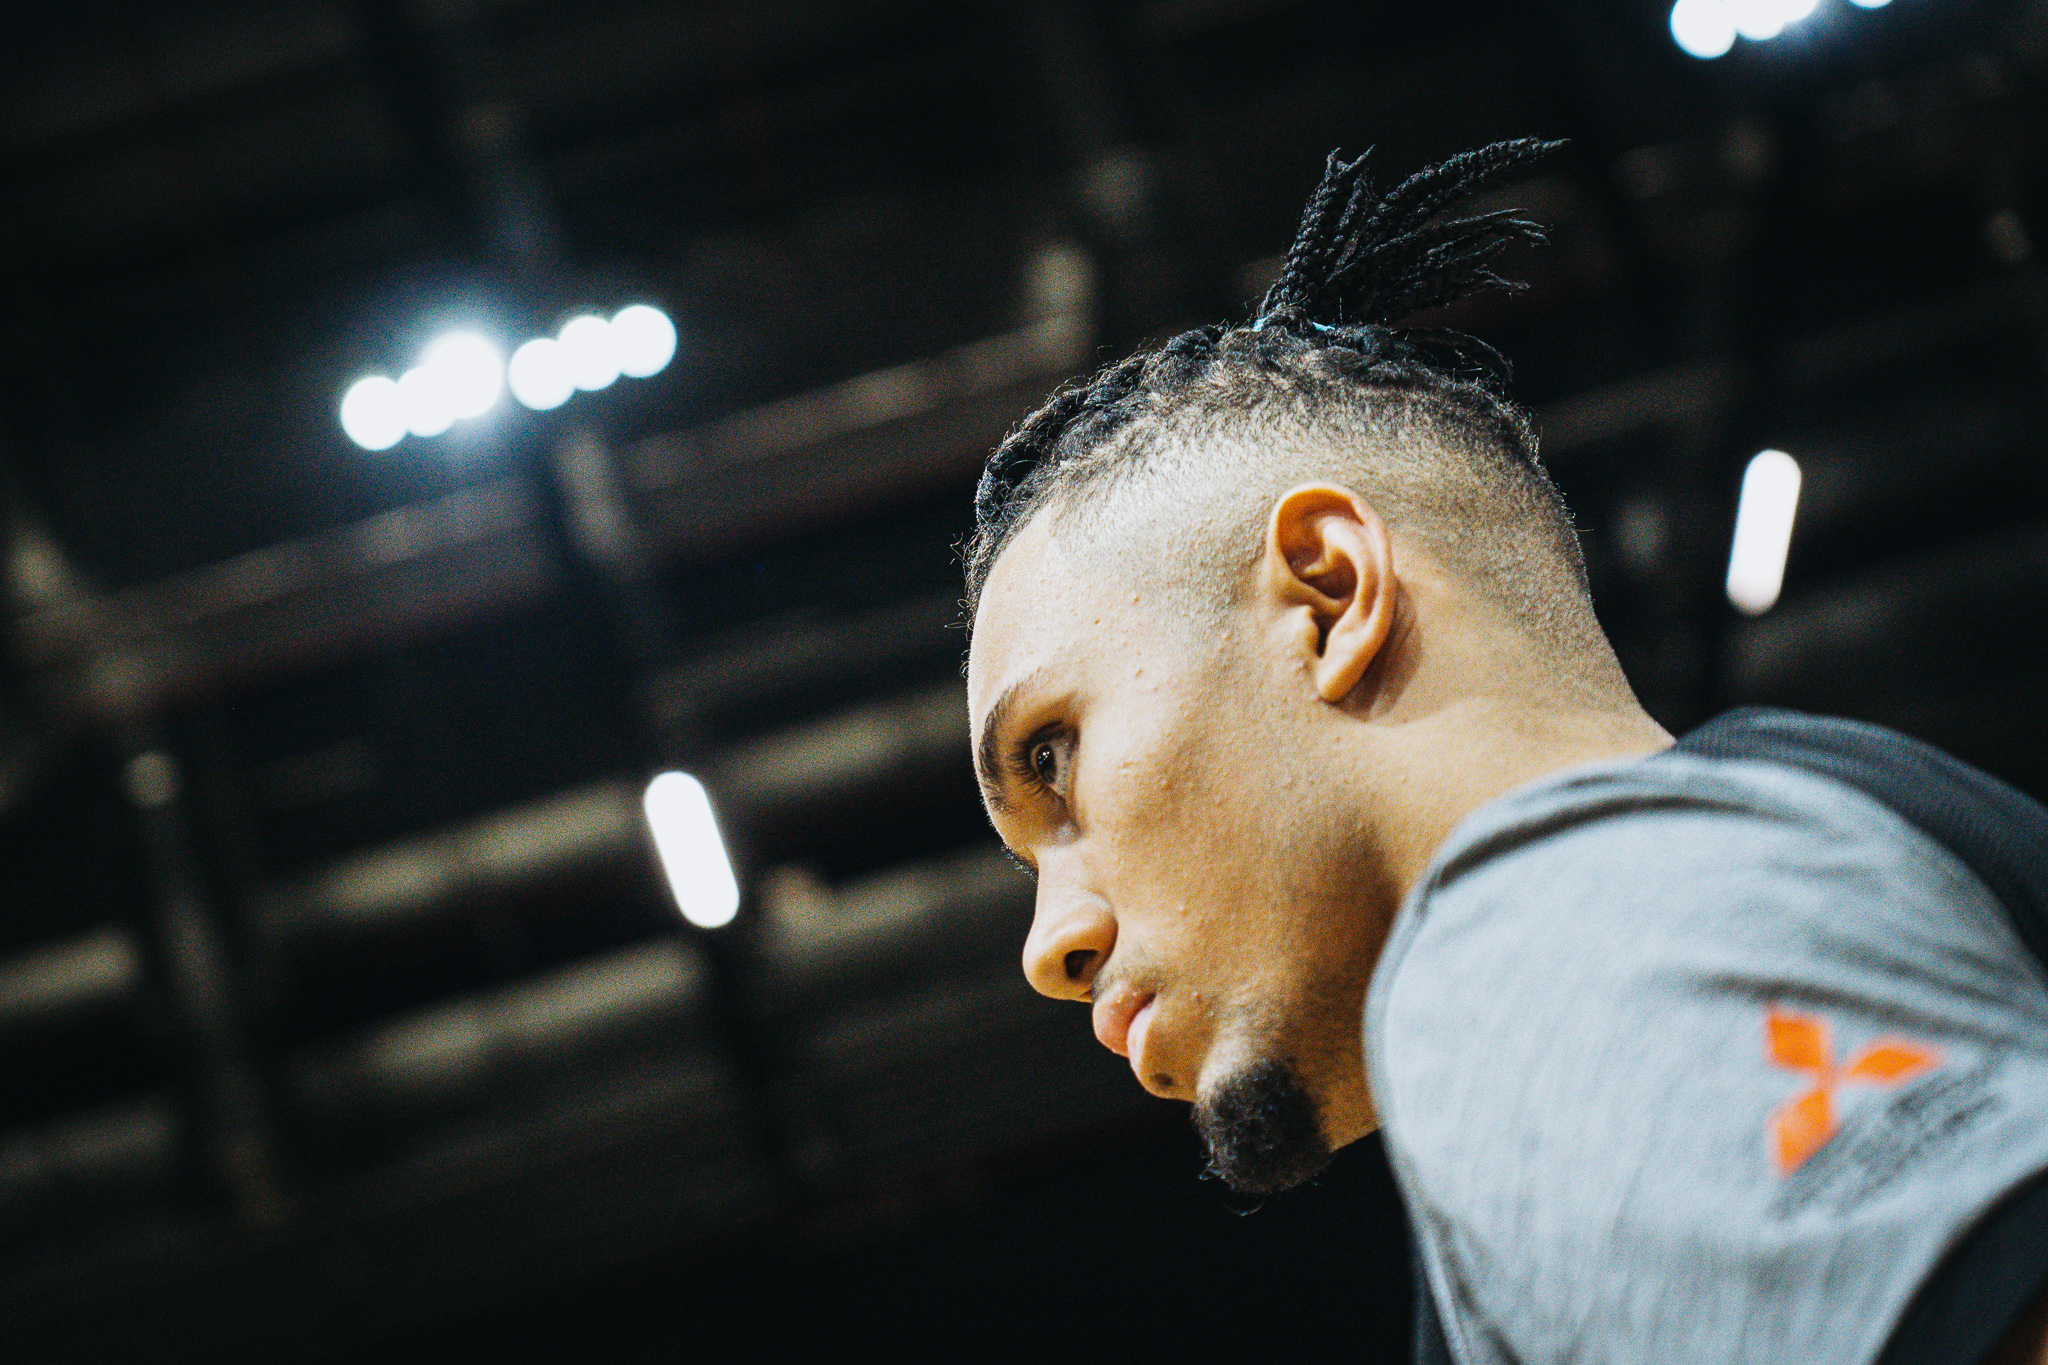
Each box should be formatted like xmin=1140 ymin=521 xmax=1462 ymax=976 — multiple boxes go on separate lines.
xmin=0 ymin=0 xmax=2048 ymax=1361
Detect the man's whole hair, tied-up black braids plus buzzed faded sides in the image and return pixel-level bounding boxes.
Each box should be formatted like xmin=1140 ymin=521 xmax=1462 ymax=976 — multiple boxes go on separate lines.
xmin=965 ymin=141 xmax=1612 ymax=673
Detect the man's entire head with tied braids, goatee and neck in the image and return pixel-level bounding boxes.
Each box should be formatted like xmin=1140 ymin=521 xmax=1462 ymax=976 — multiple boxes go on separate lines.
xmin=969 ymin=143 xmax=1662 ymax=1191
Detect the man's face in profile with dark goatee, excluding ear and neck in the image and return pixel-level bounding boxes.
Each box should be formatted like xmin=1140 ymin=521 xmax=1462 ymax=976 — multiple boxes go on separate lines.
xmin=969 ymin=516 xmax=1384 ymax=1191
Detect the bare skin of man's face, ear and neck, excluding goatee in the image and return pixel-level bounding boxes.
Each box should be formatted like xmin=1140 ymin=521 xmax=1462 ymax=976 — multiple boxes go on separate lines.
xmin=969 ymin=485 xmax=1671 ymax=1148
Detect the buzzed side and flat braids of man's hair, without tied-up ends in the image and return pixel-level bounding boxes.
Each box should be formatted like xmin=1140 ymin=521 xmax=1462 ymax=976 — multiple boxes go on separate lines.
xmin=969 ymin=329 xmax=1626 ymax=700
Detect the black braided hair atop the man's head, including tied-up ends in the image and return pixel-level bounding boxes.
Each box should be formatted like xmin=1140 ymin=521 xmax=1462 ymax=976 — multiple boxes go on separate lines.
xmin=965 ymin=139 xmax=1563 ymax=610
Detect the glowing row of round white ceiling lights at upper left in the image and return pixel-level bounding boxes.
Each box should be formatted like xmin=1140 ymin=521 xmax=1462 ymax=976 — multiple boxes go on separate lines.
xmin=342 ymin=303 xmax=676 ymax=450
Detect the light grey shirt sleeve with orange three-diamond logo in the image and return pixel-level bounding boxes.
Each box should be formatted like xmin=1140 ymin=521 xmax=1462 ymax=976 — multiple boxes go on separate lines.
xmin=1366 ymin=755 xmax=2048 ymax=1365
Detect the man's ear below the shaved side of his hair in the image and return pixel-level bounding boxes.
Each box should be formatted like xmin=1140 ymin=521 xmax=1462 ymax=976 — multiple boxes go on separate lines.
xmin=1262 ymin=483 xmax=1399 ymax=704
